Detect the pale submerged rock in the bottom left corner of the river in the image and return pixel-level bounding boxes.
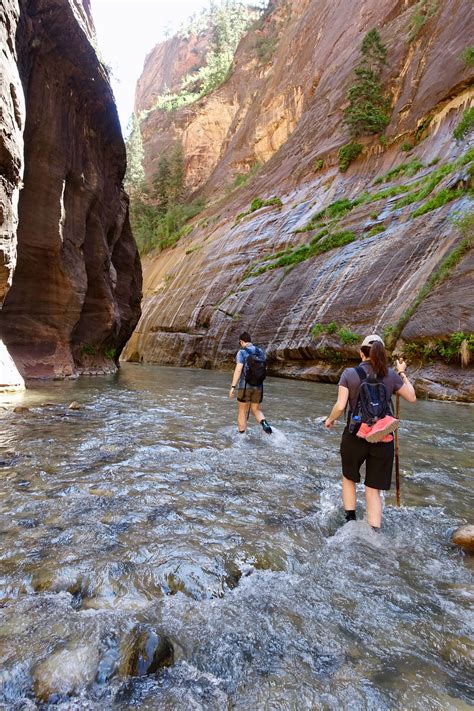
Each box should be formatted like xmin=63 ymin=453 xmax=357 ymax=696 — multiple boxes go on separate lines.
xmin=32 ymin=644 xmax=99 ymax=702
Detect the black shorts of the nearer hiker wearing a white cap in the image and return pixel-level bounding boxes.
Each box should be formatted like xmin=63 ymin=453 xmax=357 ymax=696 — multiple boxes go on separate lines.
xmin=341 ymin=427 xmax=394 ymax=491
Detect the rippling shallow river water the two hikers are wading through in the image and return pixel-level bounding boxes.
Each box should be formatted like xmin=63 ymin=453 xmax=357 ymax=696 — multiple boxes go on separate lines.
xmin=0 ymin=365 xmax=474 ymax=711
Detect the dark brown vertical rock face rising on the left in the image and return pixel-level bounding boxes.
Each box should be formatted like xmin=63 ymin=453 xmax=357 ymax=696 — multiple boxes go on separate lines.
xmin=0 ymin=0 xmax=141 ymax=384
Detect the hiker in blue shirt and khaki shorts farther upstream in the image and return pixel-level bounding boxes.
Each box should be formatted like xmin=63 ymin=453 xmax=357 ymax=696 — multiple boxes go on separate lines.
xmin=229 ymin=331 xmax=272 ymax=434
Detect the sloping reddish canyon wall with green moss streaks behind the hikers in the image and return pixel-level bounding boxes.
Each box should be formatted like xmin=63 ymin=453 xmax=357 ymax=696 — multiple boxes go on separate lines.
xmin=125 ymin=0 xmax=474 ymax=400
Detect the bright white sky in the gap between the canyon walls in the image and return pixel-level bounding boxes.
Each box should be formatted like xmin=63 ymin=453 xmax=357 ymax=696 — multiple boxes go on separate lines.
xmin=91 ymin=0 xmax=258 ymax=132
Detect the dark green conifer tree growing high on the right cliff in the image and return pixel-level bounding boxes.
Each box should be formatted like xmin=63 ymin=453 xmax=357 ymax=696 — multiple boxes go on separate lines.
xmin=344 ymin=29 xmax=390 ymax=138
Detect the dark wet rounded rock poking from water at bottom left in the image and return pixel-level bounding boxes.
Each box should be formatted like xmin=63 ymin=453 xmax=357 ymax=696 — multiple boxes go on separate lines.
xmin=119 ymin=625 xmax=174 ymax=676
